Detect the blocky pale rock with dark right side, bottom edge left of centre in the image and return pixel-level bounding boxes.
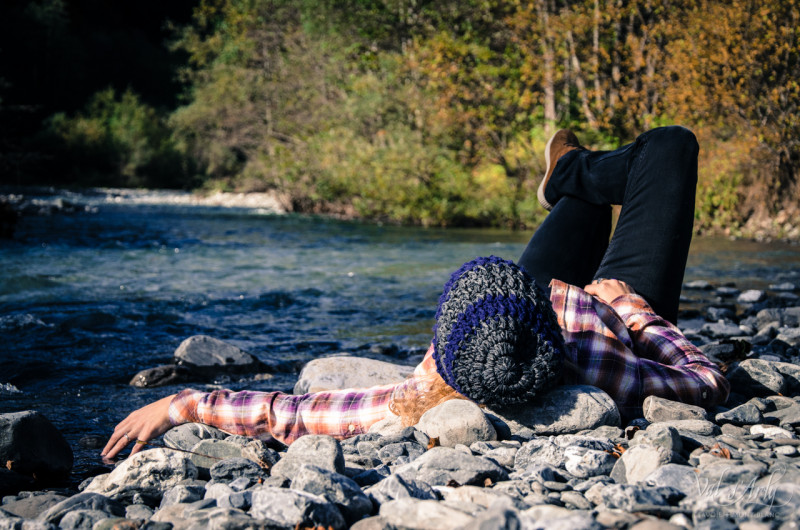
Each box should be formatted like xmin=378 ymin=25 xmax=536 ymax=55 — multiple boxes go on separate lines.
xmin=250 ymin=486 xmax=346 ymax=530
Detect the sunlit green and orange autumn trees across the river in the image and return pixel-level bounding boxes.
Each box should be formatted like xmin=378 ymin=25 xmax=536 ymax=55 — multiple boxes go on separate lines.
xmin=7 ymin=0 xmax=800 ymax=237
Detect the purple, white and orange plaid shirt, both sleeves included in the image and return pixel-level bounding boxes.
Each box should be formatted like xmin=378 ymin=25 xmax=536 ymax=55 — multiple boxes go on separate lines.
xmin=169 ymin=280 xmax=730 ymax=444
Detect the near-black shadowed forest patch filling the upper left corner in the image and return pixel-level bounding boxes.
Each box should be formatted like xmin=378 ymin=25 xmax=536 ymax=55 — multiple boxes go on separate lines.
xmin=0 ymin=0 xmax=197 ymax=184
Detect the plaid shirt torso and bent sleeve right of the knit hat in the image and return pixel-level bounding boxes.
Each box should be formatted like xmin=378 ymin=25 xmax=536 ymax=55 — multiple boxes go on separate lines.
xmin=550 ymin=280 xmax=729 ymax=415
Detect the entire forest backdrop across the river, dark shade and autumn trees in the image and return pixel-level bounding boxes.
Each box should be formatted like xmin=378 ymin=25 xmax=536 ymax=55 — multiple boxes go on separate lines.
xmin=0 ymin=0 xmax=800 ymax=238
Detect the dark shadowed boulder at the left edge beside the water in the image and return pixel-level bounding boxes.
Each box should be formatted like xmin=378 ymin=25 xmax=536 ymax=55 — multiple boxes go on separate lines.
xmin=0 ymin=410 xmax=73 ymax=483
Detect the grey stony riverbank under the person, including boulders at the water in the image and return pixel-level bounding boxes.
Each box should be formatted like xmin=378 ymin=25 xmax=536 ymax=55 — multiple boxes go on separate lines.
xmin=0 ymin=282 xmax=800 ymax=530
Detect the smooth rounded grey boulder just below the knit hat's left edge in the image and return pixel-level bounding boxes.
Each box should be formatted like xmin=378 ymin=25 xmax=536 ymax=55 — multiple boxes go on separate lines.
xmin=416 ymin=399 xmax=497 ymax=447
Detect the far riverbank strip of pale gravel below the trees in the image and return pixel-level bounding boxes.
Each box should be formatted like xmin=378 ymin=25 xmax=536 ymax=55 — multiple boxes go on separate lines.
xmin=0 ymin=186 xmax=800 ymax=244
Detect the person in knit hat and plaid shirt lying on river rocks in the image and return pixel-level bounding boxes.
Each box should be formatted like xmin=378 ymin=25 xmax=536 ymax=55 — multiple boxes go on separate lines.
xmin=102 ymin=127 xmax=730 ymax=458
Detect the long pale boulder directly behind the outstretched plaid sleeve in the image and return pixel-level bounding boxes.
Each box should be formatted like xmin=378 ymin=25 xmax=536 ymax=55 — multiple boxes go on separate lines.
xmin=294 ymin=357 xmax=414 ymax=394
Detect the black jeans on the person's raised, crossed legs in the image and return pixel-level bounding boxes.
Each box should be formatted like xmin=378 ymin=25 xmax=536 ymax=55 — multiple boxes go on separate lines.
xmin=518 ymin=126 xmax=699 ymax=323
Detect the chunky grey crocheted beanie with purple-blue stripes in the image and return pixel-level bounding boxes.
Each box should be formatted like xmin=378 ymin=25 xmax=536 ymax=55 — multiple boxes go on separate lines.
xmin=433 ymin=256 xmax=564 ymax=406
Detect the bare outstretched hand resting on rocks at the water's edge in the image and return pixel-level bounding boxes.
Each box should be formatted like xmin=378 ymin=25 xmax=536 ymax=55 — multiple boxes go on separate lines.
xmin=100 ymin=395 xmax=175 ymax=459
